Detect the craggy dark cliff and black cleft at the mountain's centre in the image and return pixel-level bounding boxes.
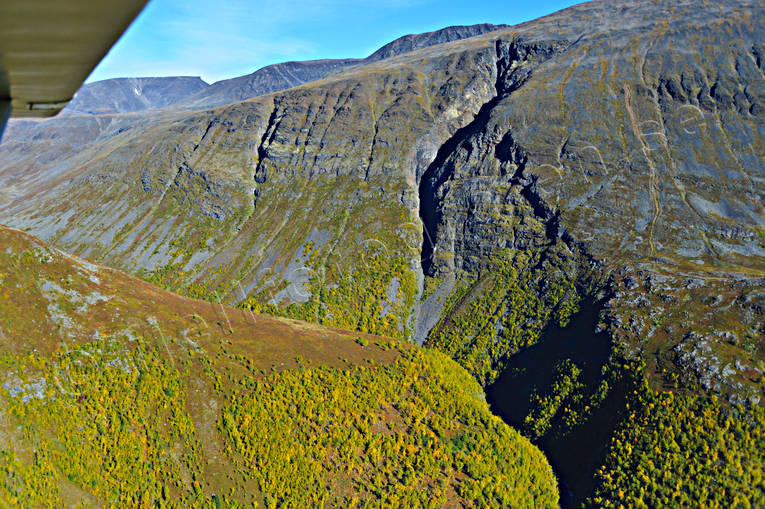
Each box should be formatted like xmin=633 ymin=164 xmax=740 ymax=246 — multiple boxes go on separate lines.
xmin=419 ymin=38 xmax=568 ymax=276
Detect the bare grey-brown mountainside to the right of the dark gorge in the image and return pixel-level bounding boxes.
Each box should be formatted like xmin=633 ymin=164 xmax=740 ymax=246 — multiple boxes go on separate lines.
xmin=426 ymin=2 xmax=765 ymax=280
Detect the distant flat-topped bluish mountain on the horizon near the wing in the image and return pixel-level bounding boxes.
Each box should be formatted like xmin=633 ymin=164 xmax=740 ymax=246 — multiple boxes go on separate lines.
xmin=64 ymin=76 xmax=210 ymax=115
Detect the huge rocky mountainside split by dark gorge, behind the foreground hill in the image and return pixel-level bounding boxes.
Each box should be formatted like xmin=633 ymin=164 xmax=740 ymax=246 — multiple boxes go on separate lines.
xmin=0 ymin=0 xmax=765 ymax=502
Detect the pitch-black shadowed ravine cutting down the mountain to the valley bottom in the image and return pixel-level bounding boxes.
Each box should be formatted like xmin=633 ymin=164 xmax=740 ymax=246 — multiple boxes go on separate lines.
xmin=418 ymin=34 xmax=626 ymax=507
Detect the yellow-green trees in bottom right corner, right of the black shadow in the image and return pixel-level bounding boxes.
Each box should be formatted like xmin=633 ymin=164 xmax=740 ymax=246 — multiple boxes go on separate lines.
xmin=587 ymin=380 xmax=765 ymax=508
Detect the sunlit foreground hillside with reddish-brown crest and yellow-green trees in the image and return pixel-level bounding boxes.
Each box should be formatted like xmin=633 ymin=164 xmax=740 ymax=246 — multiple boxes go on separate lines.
xmin=0 ymin=227 xmax=558 ymax=507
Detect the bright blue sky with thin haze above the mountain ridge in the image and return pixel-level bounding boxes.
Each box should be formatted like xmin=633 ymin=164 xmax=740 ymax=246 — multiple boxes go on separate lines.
xmin=88 ymin=0 xmax=577 ymax=83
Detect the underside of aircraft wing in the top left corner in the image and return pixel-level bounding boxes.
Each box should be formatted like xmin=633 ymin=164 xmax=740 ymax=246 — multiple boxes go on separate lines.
xmin=0 ymin=0 xmax=147 ymax=125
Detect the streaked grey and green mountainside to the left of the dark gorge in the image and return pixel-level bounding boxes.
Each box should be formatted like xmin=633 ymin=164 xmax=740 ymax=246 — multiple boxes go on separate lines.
xmin=0 ymin=35 xmax=496 ymax=335
